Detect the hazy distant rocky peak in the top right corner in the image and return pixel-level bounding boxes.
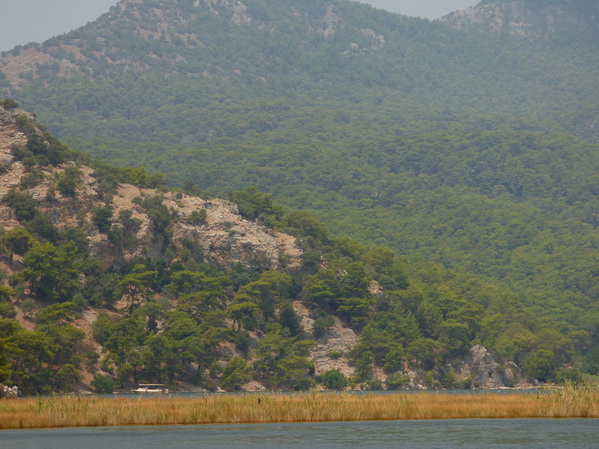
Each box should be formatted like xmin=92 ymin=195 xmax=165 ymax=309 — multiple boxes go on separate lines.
xmin=441 ymin=1 xmax=599 ymax=41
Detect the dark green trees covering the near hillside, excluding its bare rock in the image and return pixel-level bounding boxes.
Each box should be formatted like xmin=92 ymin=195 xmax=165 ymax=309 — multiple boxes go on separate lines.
xmin=0 ymin=106 xmax=598 ymax=394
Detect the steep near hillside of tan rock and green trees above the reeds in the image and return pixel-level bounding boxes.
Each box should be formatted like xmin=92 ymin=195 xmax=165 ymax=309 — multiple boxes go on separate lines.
xmin=0 ymin=106 xmax=596 ymax=393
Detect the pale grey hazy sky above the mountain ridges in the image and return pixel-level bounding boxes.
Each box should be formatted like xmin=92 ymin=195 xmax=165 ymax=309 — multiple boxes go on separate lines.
xmin=0 ymin=0 xmax=479 ymax=51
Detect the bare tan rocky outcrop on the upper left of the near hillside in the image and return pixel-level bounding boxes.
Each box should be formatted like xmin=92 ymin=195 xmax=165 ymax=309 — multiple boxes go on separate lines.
xmin=0 ymin=108 xmax=301 ymax=271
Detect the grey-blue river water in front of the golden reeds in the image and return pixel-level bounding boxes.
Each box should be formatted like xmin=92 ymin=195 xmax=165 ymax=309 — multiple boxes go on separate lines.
xmin=0 ymin=419 xmax=599 ymax=449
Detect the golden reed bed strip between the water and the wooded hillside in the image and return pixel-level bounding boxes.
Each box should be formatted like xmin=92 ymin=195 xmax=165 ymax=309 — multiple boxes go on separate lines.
xmin=0 ymin=388 xmax=599 ymax=429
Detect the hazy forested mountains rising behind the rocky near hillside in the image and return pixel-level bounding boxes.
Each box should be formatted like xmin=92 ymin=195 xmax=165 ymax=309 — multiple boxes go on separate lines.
xmin=0 ymin=0 xmax=599 ymax=388
